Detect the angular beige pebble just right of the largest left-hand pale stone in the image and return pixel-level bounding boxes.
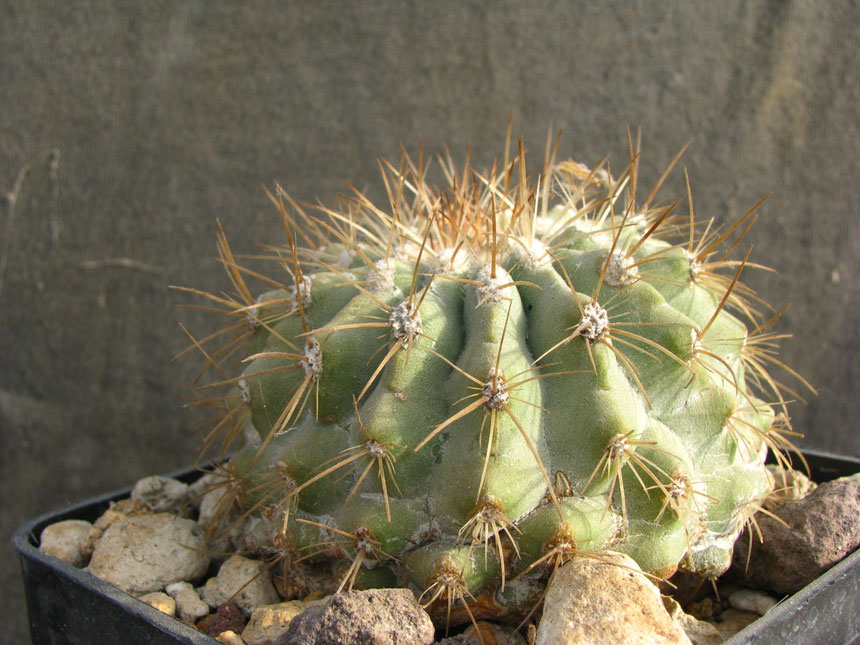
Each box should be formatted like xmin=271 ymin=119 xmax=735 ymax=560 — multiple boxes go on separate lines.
xmin=200 ymin=555 xmax=280 ymax=614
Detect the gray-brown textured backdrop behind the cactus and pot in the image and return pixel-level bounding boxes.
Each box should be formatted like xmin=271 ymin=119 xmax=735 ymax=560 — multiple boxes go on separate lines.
xmin=0 ymin=0 xmax=860 ymax=642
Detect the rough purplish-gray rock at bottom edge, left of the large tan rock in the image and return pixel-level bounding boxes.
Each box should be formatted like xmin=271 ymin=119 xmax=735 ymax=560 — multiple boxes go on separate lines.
xmin=277 ymin=589 xmax=435 ymax=645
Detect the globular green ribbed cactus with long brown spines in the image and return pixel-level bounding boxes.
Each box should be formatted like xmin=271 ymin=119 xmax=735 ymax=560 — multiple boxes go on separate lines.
xmin=183 ymin=135 xmax=802 ymax=620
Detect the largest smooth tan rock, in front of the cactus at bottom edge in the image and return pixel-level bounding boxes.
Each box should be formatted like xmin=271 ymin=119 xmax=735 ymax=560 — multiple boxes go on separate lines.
xmin=537 ymin=553 xmax=691 ymax=645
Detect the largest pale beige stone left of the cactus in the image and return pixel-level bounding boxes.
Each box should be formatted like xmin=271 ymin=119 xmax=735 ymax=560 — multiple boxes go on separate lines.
xmin=87 ymin=513 xmax=209 ymax=595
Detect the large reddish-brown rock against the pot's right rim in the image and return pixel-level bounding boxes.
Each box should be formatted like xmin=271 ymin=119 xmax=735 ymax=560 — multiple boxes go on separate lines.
xmin=732 ymin=473 xmax=860 ymax=594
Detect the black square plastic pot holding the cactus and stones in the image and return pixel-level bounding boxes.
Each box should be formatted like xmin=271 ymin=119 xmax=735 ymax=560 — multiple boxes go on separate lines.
xmin=12 ymin=451 xmax=860 ymax=645
